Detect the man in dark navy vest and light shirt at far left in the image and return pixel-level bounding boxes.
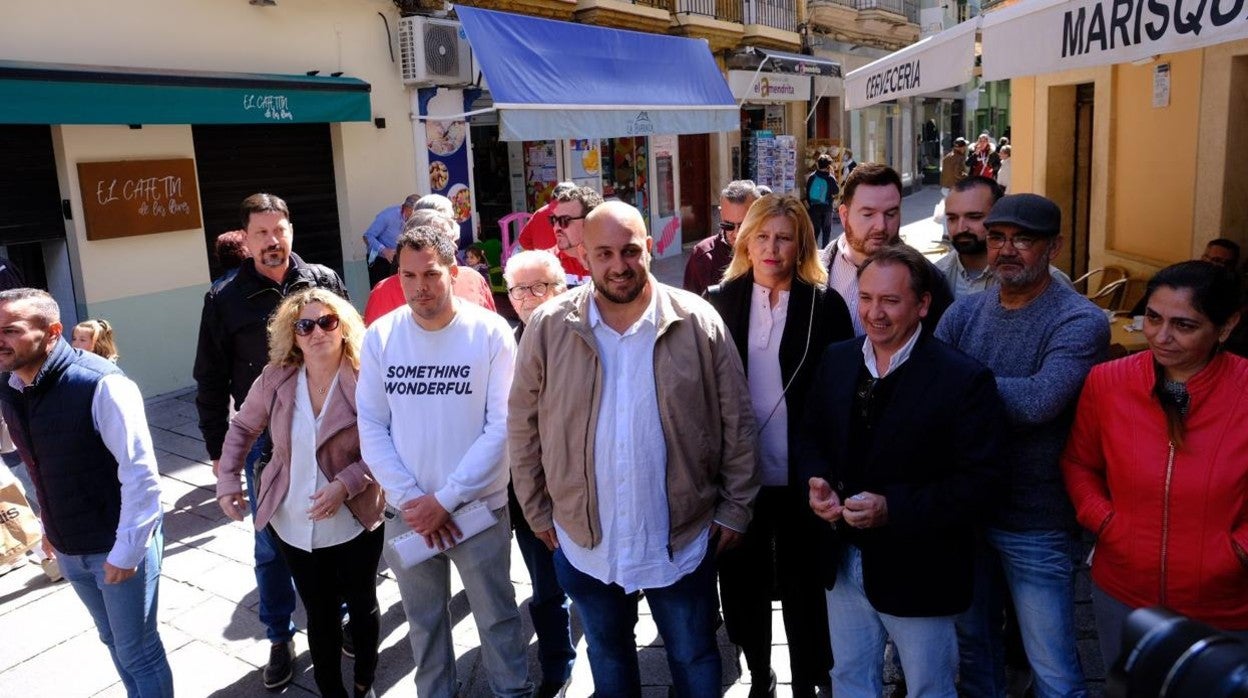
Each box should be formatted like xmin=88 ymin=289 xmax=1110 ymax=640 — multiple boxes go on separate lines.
xmin=0 ymin=288 xmax=173 ymax=698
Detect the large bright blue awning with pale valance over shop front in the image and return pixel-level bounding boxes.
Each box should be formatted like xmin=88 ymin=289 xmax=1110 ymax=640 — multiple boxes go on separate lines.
xmin=456 ymin=5 xmax=740 ymax=141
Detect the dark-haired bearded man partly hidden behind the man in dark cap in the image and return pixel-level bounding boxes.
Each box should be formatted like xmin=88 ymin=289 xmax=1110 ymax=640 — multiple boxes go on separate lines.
xmin=936 ymin=175 xmax=1075 ymax=300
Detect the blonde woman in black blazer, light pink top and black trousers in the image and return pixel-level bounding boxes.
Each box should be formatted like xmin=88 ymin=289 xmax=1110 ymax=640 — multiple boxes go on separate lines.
xmin=706 ymin=195 xmax=854 ymax=697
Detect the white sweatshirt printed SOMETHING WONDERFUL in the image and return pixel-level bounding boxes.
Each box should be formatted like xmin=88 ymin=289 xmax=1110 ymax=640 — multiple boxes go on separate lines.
xmin=356 ymin=298 xmax=515 ymax=511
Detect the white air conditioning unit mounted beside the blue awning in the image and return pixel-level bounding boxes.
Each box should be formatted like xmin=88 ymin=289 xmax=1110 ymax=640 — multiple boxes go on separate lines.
xmin=398 ymin=16 xmax=473 ymax=85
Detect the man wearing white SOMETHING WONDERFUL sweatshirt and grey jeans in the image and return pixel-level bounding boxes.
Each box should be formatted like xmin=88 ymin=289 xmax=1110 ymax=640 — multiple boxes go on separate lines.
xmin=356 ymin=226 xmax=533 ymax=696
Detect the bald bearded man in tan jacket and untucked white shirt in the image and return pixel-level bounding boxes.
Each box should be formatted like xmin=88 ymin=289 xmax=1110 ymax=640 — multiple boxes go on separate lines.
xmin=507 ymin=201 xmax=759 ymax=698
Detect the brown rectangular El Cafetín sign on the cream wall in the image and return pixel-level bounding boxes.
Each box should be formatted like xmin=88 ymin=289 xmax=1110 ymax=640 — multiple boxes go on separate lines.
xmin=79 ymin=157 xmax=202 ymax=240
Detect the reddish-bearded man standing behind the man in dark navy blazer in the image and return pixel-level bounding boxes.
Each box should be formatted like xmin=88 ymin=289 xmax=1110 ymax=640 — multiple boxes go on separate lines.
xmin=819 ymin=162 xmax=953 ymax=337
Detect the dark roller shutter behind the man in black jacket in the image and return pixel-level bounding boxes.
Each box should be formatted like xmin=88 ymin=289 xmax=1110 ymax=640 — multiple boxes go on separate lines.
xmin=191 ymin=124 xmax=342 ymax=278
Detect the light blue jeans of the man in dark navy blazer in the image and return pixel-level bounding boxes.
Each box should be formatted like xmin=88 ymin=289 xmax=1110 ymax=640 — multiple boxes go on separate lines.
xmin=827 ymin=546 xmax=957 ymax=698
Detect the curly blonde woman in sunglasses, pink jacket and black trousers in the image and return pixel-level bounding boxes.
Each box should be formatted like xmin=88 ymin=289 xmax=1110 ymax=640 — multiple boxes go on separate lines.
xmin=217 ymin=288 xmax=384 ymax=697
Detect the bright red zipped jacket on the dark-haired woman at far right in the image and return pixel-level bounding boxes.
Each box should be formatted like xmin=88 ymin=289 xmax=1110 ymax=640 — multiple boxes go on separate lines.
xmin=1062 ymin=351 xmax=1248 ymax=631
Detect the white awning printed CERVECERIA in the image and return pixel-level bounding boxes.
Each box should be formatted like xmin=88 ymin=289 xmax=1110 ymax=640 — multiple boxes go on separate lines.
xmin=845 ymin=17 xmax=980 ymax=110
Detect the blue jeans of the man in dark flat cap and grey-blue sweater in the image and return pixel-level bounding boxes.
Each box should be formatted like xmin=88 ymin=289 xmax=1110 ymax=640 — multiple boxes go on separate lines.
xmin=958 ymin=528 xmax=1087 ymax=698
